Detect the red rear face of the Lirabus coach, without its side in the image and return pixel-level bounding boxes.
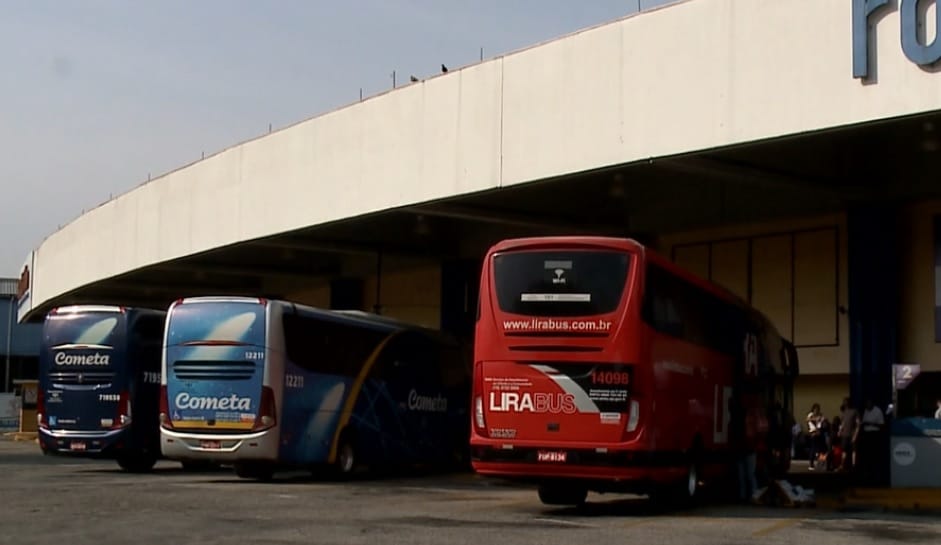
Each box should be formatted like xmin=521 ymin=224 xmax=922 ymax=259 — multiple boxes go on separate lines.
xmin=472 ymin=240 xmax=646 ymax=477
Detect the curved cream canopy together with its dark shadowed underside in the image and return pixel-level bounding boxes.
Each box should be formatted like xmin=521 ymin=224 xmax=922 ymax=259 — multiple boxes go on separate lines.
xmin=20 ymin=0 xmax=941 ymax=320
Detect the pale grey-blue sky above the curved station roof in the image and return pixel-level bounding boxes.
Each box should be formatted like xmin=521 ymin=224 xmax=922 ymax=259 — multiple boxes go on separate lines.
xmin=0 ymin=0 xmax=674 ymax=277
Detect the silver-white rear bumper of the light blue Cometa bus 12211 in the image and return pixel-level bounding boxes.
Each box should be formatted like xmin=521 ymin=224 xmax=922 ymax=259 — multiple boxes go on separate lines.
xmin=160 ymin=427 xmax=280 ymax=463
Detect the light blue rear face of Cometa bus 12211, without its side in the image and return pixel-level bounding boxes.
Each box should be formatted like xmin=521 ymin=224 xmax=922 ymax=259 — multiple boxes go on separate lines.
xmin=160 ymin=298 xmax=278 ymax=462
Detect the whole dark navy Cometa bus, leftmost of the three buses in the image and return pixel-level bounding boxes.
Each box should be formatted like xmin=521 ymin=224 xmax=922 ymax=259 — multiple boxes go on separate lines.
xmin=37 ymin=305 xmax=166 ymax=472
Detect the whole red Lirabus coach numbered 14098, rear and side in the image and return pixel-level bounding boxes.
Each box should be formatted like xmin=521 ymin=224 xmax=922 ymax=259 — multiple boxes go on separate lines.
xmin=470 ymin=237 xmax=798 ymax=505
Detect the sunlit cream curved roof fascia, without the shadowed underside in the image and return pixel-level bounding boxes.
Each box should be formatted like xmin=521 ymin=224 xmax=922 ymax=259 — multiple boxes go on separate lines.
xmin=21 ymin=0 xmax=941 ymax=317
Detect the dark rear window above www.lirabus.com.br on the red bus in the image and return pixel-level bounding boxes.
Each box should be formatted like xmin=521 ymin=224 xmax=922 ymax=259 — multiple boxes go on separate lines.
xmin=493 ymin=250 xmax=630 ymax=316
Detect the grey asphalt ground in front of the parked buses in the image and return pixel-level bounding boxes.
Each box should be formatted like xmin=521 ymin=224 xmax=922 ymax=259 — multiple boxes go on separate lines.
xmin=0 ymin=440 xmax=941 ymax=545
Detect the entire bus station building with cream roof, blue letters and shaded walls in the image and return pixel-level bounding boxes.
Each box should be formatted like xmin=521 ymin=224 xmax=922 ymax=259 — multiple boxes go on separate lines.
xmin=17 ymin=0 xmax=941 ymax=421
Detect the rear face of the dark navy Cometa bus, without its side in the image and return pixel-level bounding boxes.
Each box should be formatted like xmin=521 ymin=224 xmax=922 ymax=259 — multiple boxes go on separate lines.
xmin=43 ymin=312 xmax=130 ymax=442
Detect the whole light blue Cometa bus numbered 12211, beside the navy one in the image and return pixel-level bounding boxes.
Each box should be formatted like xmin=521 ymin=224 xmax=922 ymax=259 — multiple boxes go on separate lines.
xmin=160 ymin=297 xmax=470 ymax=479
